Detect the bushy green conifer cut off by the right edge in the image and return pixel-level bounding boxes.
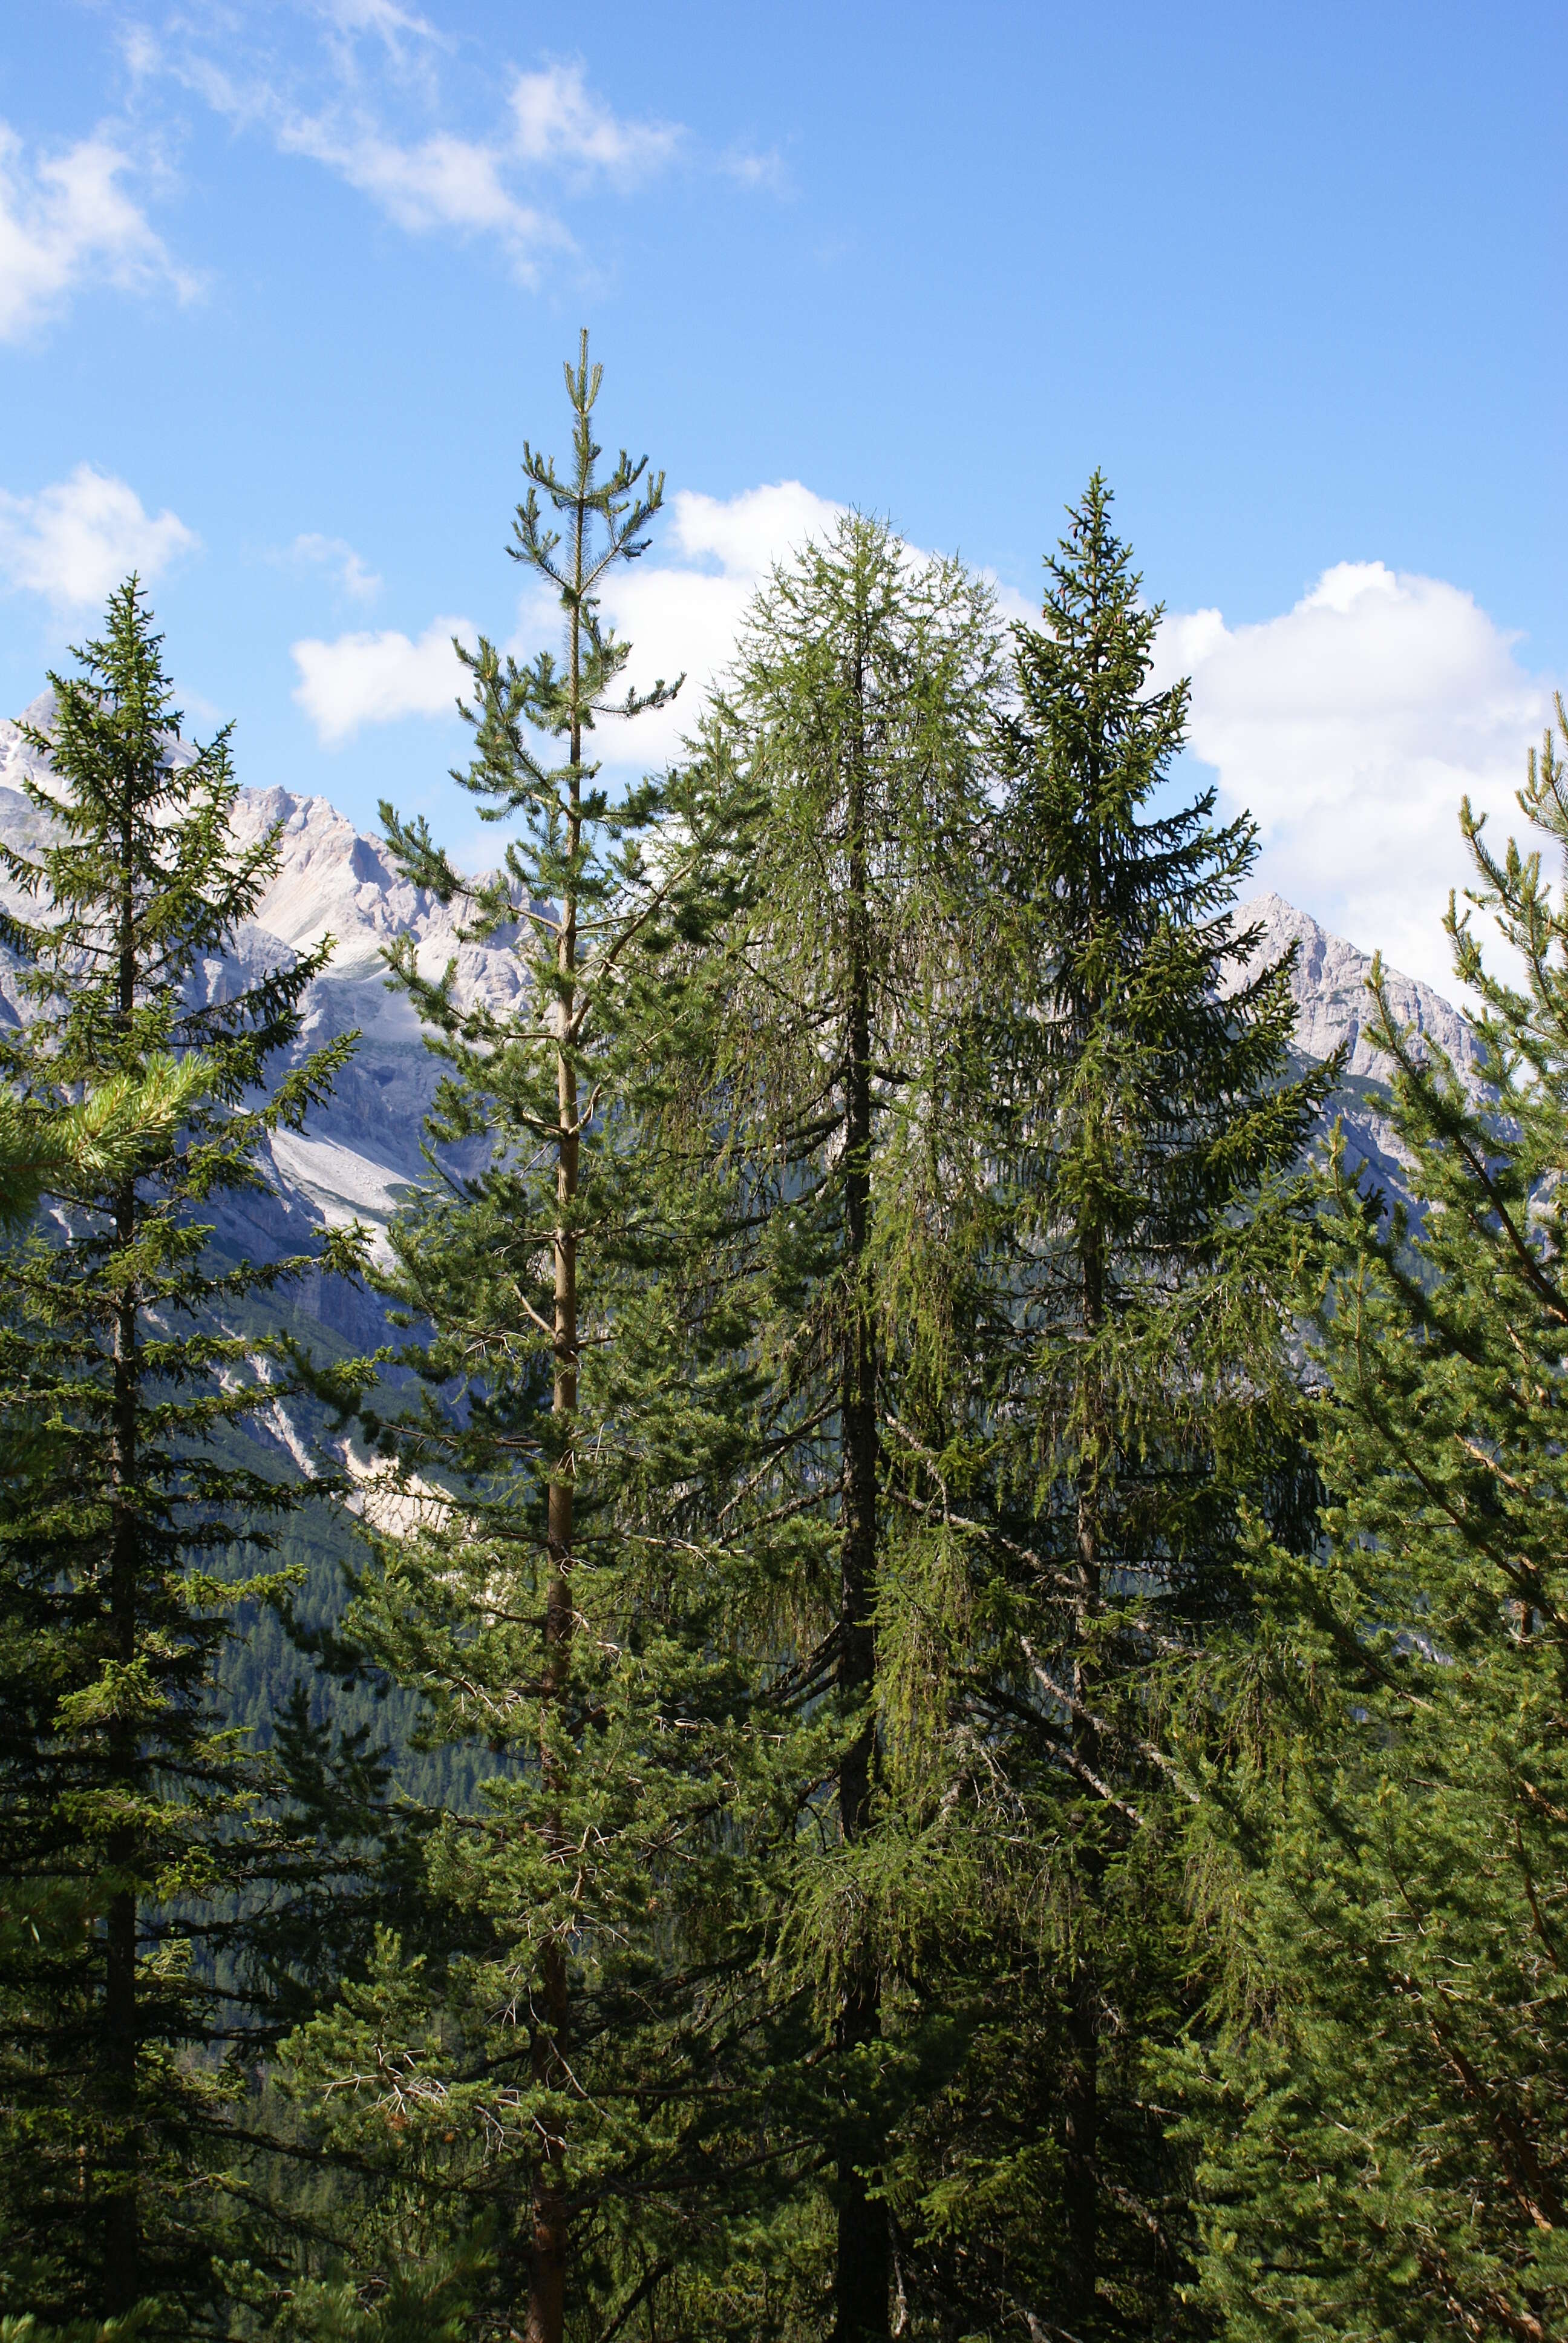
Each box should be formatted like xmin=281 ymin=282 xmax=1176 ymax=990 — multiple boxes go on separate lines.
xmin=1188 ymin=703 xmax=1568 ymax=2343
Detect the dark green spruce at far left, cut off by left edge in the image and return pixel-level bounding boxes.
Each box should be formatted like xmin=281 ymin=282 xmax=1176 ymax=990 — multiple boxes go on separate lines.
xmin=0 ymin=578 xmax=354 ymax=2324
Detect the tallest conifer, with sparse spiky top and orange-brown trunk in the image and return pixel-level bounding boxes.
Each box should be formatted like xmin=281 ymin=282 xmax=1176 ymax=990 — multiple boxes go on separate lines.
xmin=279 ymin=338 xmax=769 ymax=2343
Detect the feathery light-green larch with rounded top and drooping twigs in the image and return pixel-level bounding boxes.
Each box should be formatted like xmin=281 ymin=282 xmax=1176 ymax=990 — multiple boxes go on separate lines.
xmin=679 ymin=516 xmax=999 ymax=2343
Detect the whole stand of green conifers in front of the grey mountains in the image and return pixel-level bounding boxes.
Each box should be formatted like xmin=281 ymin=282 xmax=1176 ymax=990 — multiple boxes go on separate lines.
xmin=0 ymin=356 xmax=1568 ymax=2343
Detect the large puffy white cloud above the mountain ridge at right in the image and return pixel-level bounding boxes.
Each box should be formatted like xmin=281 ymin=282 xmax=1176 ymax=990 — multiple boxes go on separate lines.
xmin=1158 ymin=562 xmax=1549 ymax=989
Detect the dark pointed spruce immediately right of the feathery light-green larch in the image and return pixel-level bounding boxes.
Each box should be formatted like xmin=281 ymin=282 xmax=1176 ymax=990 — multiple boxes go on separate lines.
xmin=895 ymin=476 xmax=1331 ymax=2343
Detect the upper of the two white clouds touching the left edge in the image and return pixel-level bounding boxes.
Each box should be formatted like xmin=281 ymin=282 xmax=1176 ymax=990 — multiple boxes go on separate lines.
xmin=0 ymin=122 xmax=195 ymax=342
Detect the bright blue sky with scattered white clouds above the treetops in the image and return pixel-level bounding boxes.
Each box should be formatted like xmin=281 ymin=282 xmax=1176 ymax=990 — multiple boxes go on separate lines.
xmin=0 ymin=0 xmax=1568 ymax=977
